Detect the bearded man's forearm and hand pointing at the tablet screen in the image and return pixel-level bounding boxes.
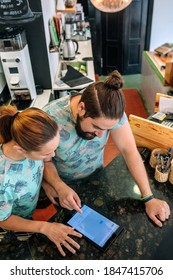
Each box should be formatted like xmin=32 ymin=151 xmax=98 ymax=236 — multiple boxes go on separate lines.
xmin=43 ymin=161 xmax=82 ymax=213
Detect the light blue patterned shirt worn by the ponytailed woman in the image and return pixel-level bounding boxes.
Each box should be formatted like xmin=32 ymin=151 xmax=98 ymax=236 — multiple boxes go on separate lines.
xmin=0 ymin=146 xmax=44 ymax=221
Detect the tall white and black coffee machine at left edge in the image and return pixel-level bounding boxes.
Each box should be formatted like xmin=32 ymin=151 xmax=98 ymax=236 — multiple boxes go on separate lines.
xmin=0 ymin=27 xmax=36 ymax=110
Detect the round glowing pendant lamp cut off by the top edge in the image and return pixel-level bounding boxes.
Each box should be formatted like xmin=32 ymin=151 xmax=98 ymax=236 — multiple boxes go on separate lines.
xmin=91 ymin=0 xmax=132 ymax=13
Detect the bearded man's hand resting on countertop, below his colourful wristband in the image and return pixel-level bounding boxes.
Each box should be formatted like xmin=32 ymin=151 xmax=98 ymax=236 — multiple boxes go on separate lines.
xmin=145 ymin=198 xmax=170 ymax=227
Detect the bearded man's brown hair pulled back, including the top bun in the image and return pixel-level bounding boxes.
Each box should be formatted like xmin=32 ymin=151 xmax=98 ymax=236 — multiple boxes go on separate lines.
xmin=80 ymin=70 xmax=125 ymax=119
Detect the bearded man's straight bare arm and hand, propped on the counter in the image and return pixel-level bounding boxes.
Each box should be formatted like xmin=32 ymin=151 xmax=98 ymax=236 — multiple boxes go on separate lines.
xmin=111 ymin=122 xmax=170 ymax=227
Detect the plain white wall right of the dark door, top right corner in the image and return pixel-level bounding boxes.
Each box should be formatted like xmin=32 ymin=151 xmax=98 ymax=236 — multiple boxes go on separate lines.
xmin=149 ymin=0 xmax=173 ymax=51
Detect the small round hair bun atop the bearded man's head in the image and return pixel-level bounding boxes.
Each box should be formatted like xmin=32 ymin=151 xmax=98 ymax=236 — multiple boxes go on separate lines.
xmin=104 ymin=70 xmax=123 ymax=90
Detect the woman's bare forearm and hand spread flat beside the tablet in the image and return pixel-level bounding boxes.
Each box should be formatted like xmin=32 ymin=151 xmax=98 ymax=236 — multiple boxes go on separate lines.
xmin=0 ymin=215 xmax=82 ymax=256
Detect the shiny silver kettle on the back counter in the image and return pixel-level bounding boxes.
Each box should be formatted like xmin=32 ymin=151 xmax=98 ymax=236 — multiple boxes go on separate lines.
xmin=63 ymin=39 xmax=79 ymax=60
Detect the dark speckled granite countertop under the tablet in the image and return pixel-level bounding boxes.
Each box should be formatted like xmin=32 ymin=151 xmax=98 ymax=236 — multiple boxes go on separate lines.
xmin=0 ymin=155 xmax=173 ymax=260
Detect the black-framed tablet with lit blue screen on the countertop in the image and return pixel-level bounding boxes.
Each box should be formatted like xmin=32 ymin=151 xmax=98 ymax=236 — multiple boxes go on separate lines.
xmin=65 ymin=204 xmax=124 ymax=251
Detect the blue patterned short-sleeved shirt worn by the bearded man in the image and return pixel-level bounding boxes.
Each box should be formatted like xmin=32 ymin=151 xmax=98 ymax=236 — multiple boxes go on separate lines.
xmin=44 ymin=96 xmax=127 ymax=181
